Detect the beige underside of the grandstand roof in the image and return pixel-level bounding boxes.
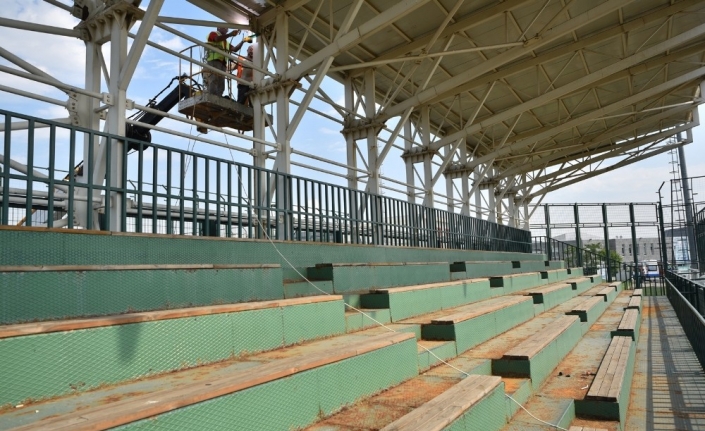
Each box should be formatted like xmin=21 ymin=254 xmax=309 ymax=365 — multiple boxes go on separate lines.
xmin=188 ymin=0 xmax=705 ymax=193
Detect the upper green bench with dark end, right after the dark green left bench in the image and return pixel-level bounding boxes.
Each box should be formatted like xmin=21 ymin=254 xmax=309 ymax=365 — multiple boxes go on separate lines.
xmin=307 ymin=262 xmax=450 ymax=294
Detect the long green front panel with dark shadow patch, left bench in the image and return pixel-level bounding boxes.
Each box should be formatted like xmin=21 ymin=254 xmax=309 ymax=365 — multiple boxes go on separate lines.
xmin=0 ymin=308 xmax=283 ymax=404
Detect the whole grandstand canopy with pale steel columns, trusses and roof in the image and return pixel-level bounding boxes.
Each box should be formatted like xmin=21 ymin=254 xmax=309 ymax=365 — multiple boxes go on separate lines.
xmin=0 ymin=0 xmax=705 ymax=231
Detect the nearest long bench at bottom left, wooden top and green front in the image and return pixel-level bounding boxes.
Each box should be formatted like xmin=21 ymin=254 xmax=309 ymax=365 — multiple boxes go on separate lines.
xmin=0 ymin=333 xmax=418 ymax=430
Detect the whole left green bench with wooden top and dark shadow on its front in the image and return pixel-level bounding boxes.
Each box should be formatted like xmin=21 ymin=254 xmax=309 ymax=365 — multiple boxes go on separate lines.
xmin=0 ymin=296 xmax=345 ymax=405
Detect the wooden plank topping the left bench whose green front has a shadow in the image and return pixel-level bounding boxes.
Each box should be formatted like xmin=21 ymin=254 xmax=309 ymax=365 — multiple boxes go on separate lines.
xmin=0 ymin=295 xmax=343 ymax=339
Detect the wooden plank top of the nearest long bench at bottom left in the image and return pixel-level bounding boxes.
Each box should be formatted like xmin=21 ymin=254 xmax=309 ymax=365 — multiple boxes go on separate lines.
xmin=11 ymin=333 xmax=414 ymax=431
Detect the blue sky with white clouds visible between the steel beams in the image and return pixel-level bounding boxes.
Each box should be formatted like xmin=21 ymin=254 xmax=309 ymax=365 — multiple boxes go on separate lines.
xmin=0 ymin=0 xmax=705 ymax=209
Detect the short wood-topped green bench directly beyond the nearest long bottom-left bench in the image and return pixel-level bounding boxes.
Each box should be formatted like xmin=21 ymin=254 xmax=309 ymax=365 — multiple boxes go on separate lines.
xmin=420 ymin=296 xmax=534 ymax=353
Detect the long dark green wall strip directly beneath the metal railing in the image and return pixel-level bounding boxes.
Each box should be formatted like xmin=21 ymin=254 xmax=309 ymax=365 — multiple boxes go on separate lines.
xmin=0 ymin=230 xmax=545 ymax=270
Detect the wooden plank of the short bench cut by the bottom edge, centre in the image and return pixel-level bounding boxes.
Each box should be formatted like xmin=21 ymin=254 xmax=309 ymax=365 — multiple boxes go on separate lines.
xmin=382 ymin=375 xmax=502 ymax=431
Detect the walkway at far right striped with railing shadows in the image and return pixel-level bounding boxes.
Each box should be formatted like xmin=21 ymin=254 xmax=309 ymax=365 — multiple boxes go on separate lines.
xmin=626 ymin=296 xmax=705 ymax=431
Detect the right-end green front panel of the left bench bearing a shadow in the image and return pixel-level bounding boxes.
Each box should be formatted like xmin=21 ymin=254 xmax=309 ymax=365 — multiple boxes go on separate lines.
xmin=282 ymin=301 xmax=345 ymax=344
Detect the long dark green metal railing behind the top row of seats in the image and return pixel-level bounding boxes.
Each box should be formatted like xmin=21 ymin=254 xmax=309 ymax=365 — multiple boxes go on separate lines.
xmin=0 ymin=110 xmax=531 ymax=253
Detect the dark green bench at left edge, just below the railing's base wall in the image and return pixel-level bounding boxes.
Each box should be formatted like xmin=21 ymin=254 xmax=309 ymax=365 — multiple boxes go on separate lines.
xmin=0 ymin=264 xmax=284 ymax=324
